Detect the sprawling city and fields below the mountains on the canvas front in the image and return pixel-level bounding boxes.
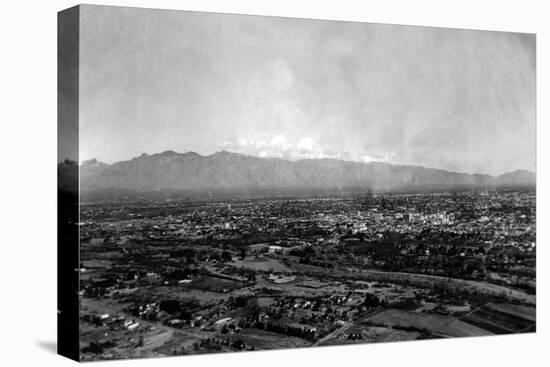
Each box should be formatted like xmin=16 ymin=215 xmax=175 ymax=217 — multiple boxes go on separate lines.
xmin=78 ymin=189 xmax=536 ymax=360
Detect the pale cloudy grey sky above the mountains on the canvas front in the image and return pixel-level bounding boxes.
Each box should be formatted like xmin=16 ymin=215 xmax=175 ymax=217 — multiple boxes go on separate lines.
xmin=80 ymin=6 xmax=536 ymax=174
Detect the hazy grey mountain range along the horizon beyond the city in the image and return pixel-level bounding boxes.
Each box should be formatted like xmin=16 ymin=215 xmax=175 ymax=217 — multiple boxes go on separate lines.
xmin=59 ymin=151 xmax=536 ymax=200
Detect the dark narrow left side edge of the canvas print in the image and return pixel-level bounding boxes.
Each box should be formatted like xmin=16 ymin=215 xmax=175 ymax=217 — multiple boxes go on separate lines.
xmin=57 ymin=6 xmax=80 ymax=361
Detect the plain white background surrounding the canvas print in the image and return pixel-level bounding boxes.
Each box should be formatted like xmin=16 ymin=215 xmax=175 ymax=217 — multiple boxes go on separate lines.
xmin=0 ymin=0 xmax=550 ymax=367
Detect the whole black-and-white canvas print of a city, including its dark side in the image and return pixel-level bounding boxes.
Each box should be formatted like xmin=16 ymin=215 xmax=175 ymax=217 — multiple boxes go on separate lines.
xmin=57 ymin=5 xmax=536 ymax=361
